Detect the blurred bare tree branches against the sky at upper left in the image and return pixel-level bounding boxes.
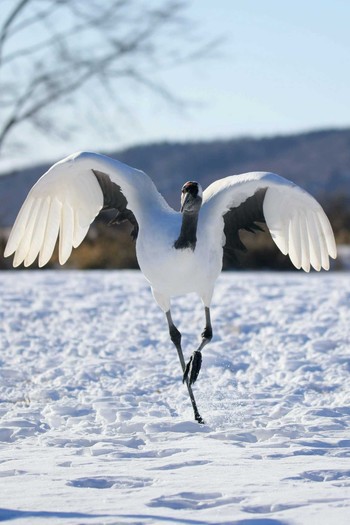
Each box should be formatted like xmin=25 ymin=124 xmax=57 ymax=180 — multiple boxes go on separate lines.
xmin=0 ymin=0 xmax=217 ymax=156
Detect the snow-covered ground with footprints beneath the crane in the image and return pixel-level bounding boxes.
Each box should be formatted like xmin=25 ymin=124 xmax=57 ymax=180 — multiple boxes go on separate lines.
xmin=0 ymin=271 xmax=350 ymax=525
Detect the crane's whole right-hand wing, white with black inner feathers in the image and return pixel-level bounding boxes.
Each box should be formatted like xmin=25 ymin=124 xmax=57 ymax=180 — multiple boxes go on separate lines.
xmin=201 ymin=172 xmax=337 ymax=272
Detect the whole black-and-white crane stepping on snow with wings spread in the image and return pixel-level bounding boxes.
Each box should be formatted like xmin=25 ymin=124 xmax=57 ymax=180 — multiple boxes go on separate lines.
xmin=5 ymin=152 xmax=336 ymax=423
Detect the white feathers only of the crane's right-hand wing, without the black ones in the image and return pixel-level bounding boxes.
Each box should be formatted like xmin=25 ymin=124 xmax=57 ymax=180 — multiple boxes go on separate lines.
xmin=202 ymin=172 xmax=337 ymax=272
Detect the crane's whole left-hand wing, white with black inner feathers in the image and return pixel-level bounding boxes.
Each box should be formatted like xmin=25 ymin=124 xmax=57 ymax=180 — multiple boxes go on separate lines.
xmin=4 ymin=152 xmax=167 ymax=267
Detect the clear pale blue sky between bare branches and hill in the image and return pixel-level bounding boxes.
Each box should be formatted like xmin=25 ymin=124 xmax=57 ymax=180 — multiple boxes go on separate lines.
xmin=2 ymin=0 xmax=350 ymax=168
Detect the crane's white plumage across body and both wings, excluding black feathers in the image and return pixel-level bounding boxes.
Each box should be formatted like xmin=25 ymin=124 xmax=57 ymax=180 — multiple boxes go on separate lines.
xmin=5 ymin=149 xmax=336 ymax=311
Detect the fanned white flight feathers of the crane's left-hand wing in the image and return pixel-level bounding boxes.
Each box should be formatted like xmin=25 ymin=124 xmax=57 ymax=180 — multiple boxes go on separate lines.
xmin=5 ymin=161 xmax=103 ymax=267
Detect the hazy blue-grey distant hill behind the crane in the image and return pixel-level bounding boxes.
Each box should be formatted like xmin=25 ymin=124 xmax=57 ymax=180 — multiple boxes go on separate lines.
xmin=0 ymin=129 xmax=350 ymax=227
